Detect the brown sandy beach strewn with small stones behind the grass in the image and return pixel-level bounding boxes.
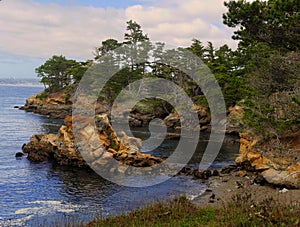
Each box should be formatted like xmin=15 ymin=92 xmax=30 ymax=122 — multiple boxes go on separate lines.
xmin=192 ymin=170 xmax=300 ymax=208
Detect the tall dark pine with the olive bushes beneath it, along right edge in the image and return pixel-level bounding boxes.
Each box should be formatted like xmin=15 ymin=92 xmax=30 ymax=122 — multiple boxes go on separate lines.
xmin=223 ymin=0 xmax=300 ymax=138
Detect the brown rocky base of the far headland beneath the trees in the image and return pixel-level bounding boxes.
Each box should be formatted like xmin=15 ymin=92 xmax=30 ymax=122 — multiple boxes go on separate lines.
xmin=20 ymin=88 xmax=243 ymax=134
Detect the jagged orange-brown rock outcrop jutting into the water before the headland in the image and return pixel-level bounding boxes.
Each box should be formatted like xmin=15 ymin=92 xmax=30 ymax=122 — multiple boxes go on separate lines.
xmin=23 ymin=114 xmax=163 ymax=167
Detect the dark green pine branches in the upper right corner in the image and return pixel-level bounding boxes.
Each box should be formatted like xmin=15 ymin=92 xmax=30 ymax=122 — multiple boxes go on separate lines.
xmin=223 ymin=0 xmax=300 ymax=50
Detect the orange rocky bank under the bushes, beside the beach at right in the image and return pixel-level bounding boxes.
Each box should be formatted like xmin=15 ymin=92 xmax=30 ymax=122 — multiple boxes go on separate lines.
xmin=235 ymin=132 xmax=300 ymax=188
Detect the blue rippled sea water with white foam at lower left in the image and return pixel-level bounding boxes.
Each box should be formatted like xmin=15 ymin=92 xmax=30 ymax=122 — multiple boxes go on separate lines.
xmin=0 ymin=85 xmax=237 ymax=226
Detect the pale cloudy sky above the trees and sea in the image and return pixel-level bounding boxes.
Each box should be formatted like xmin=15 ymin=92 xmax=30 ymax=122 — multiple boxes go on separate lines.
xmin=0 ymin=0 xmax=236 ymax=78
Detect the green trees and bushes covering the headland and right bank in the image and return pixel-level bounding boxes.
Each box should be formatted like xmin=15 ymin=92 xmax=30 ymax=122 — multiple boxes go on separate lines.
xmin=36 ymin=15 xmax=300 ymax=140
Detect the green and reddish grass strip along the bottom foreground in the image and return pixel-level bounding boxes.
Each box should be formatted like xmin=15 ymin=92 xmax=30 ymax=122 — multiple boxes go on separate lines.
xmin=87 ymin=194 xmax=300 ymax=227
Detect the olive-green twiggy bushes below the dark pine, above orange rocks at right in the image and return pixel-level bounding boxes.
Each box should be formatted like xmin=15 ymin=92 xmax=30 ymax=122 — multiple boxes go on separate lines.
xmin=242 ymin=45 xmax=300 ymax=138
